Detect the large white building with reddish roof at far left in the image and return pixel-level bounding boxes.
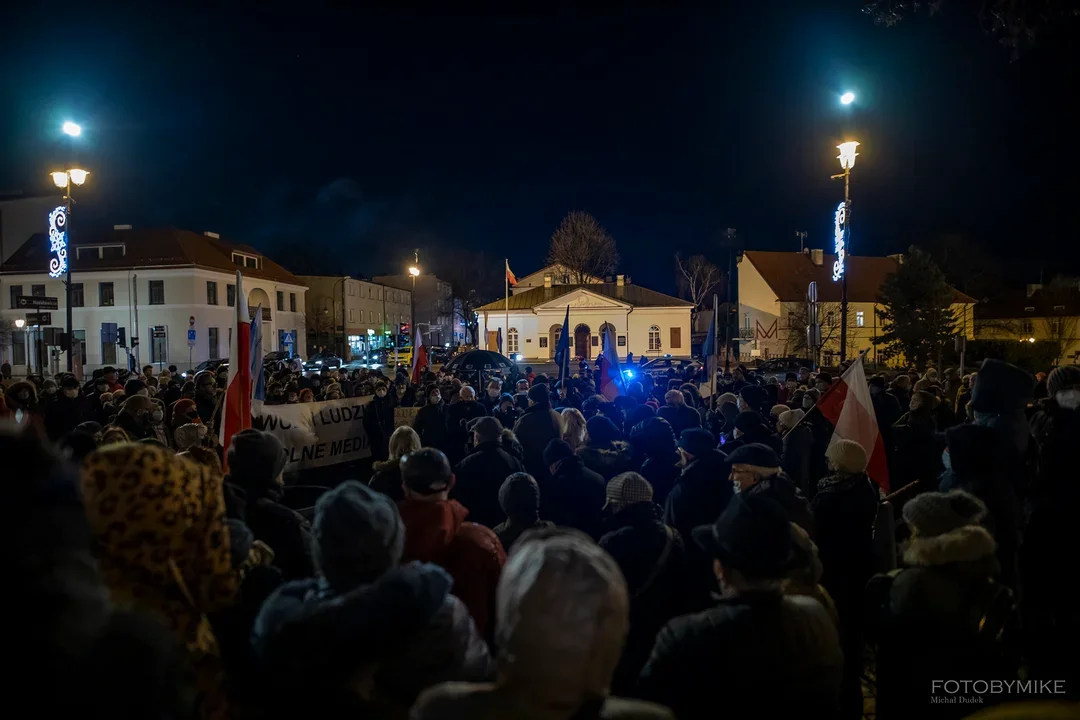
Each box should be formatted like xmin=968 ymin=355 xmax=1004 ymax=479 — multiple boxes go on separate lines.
xmin=0 ymin=225 xmax=307 ymax=375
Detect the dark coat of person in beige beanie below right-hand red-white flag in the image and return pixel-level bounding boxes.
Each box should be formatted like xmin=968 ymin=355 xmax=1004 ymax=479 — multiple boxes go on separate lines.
xmin=810 ymin=473 xmax=878 ymax=621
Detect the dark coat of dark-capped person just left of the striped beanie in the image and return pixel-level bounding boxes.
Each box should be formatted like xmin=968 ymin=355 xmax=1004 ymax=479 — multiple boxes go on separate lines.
xmin=537 ymin=456 xmax=607 ymax=538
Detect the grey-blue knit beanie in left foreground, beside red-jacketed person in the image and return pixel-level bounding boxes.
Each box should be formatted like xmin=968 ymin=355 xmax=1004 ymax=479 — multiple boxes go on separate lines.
xmin=311 ymin=480 xmax=405 ymax=592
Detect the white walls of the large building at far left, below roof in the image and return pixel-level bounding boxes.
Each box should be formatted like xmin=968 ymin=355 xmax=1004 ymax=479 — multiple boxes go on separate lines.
xmin=0 ymin=268 xmax=307 ymax=373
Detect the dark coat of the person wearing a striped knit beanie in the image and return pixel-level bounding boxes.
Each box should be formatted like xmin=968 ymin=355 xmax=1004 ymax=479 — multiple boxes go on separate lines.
xmin=599 ymin=503 xmax=691 ymax=693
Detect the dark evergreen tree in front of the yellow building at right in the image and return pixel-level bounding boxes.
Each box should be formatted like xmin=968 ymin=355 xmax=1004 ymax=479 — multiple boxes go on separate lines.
xmin=877 ymin=245 xmax=957 ymax=368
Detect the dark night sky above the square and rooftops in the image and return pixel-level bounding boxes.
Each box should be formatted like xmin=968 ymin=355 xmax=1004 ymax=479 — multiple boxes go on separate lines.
xmin=0 ymin=0 xmax=1080 ymax=291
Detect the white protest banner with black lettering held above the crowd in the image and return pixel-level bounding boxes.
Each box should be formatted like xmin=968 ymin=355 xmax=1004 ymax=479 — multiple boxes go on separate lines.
xmin=255 ymin=395 xmax=372 ymax=473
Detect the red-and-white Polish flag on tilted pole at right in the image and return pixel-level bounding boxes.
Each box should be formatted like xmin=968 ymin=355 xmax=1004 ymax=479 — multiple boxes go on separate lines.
xmin=818 ymin=356 xmax=889 ymax=492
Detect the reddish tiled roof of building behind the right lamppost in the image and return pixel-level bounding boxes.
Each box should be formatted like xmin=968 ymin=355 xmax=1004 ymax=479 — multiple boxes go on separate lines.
xmin=743 ymin=250 xmax=975 ymax=302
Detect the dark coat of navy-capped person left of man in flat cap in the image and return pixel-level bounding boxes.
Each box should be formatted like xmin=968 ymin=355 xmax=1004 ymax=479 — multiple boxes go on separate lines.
xmin=664 ymin=450 xmax=734 ymax=546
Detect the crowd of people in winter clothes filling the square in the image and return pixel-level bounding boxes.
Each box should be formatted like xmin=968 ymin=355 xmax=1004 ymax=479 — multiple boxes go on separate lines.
xmin=0 ymin=359 xmax=1080 ymax=720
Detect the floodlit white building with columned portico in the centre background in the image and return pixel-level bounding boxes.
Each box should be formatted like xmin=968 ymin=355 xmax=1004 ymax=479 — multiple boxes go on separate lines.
xmin=476 ymin=273 xmax=692 ymax=363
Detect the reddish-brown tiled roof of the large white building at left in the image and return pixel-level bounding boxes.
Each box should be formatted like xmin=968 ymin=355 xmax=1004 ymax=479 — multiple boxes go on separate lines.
xmin=3 ymin=228 xmax=303 ymax=287
